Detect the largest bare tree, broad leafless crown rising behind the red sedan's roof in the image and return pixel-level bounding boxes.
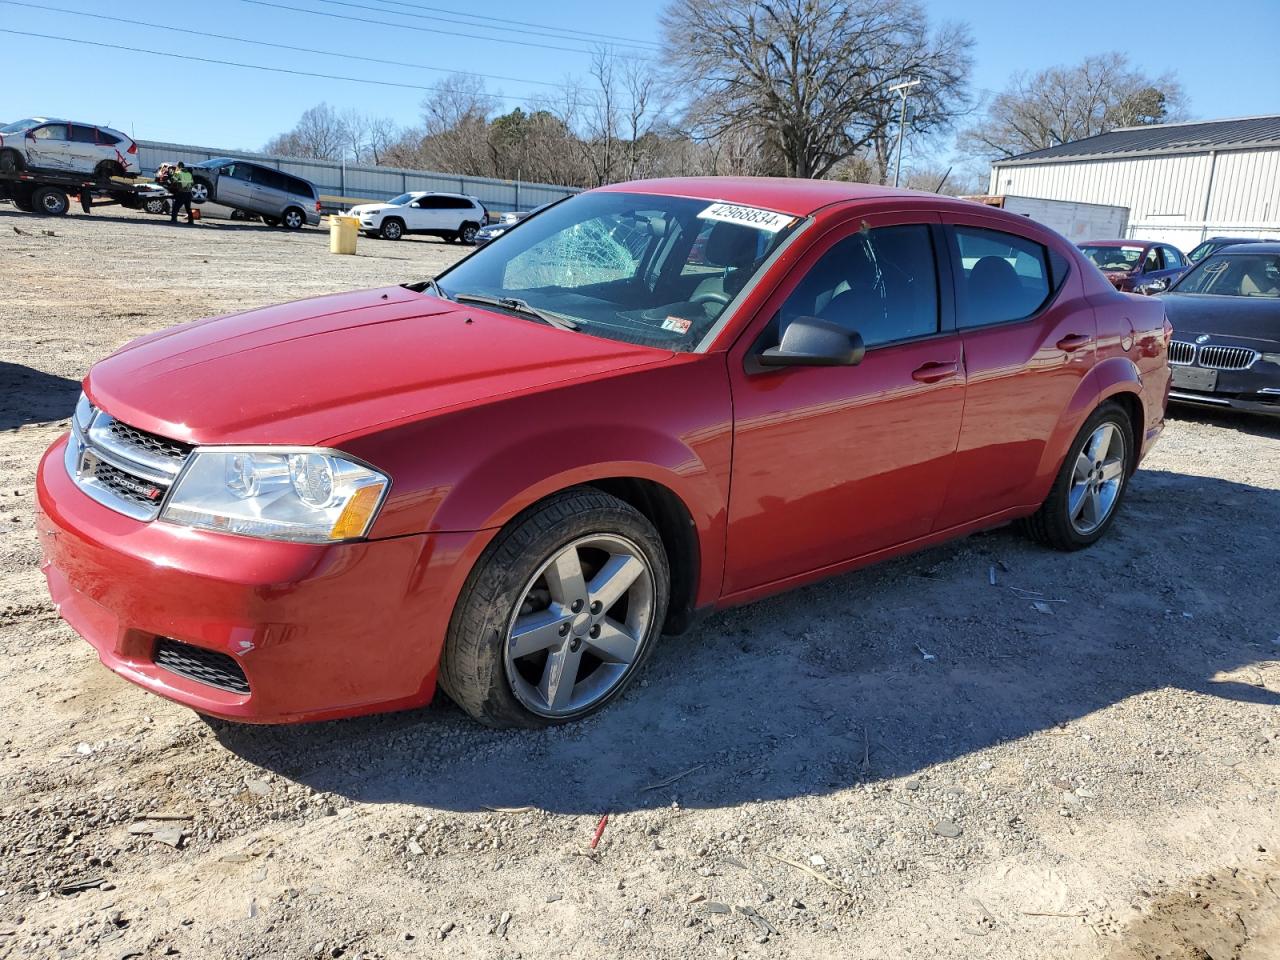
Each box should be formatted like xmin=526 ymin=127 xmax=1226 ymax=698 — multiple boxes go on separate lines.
xmin=662 ymin=0 xmax=972 ymax=177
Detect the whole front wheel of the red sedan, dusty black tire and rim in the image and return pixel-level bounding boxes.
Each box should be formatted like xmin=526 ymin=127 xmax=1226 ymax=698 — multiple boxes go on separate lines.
xmin=439 ymin=486 xmax=671 ymax=728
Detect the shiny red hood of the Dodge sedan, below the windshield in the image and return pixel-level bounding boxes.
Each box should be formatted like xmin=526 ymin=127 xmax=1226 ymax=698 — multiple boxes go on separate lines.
xmin=84 ymin=287 xmax=673 ymax=444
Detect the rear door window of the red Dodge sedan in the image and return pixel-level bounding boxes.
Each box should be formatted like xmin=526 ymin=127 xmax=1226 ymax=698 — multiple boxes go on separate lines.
xmin=952 ymin=227 xmax=1049 ymax=329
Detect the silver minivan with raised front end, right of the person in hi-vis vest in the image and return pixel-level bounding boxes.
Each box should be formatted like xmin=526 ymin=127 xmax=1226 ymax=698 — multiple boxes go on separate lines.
xmin=191 ymin=156 xmax=320 ymax=230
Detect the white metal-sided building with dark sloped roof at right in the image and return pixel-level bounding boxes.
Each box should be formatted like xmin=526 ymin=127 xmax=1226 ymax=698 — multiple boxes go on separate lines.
xmin=991 ymin=116 xmax=1280 ymax=251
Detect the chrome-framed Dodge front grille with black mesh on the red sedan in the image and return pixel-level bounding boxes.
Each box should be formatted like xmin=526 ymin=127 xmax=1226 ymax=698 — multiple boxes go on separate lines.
xmin=64 ymin=404 xmax=192 ymax=521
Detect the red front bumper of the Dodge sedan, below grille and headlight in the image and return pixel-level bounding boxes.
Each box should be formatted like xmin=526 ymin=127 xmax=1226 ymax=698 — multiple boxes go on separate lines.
xmin=36 ymin=436 xmax=476 ymax=723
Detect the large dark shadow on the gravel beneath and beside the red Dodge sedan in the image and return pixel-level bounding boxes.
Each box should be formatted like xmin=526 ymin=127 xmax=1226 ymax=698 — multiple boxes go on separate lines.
xmin=210 ymin=471 xmax=1280 ymax=814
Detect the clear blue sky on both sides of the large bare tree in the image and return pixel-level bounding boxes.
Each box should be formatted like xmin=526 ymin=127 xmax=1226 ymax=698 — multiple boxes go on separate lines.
xmin=0 ymin=0 xmax=1280 ymax=161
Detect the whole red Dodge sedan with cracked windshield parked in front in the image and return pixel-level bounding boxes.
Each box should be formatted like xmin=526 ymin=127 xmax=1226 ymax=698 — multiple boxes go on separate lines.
xmin=38 ymin=179 xmax=1170 ymax=726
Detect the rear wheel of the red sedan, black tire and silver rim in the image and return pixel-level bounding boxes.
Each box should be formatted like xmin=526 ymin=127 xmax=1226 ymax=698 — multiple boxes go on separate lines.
xmin=1021 ymin=402 xmax=1137 ymax=550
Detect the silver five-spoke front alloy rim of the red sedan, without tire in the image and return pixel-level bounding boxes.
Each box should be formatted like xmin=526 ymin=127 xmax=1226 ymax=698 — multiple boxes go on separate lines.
xmin=503 ymin=534 xmax=655 ymax=718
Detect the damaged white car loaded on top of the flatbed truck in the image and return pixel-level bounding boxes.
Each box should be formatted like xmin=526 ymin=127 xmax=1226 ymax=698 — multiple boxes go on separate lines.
xmin=0 ymin=116 xmax=142 ymax=179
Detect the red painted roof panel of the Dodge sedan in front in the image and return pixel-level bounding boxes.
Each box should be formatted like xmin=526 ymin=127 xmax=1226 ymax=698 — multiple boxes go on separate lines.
xmin=596 ymin=177 xmax=931 ymax=216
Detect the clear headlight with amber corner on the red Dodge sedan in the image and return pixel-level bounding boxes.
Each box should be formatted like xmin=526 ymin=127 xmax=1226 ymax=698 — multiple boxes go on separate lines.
xmin=160 ymin=447 xmax=390 ymax=543
